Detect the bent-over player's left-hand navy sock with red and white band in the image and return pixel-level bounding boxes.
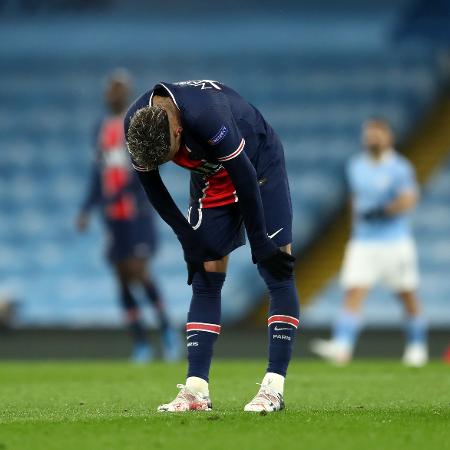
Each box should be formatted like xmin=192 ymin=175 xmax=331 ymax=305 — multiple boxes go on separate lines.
xmin=186 ymin=272 xmax=225 ymax=381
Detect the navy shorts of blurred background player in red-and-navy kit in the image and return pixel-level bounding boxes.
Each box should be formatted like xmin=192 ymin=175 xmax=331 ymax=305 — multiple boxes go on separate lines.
xmin=106 ymin=218 xmax=156 ymax=264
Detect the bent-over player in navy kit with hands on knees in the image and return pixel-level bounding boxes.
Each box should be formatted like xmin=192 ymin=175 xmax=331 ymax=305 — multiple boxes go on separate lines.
xmin=125 ymin=80 xmax=299 ymax=412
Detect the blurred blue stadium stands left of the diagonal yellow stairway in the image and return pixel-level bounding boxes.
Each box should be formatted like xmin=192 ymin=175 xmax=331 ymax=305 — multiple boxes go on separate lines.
xmin=0 ymin=1 xmax=441 ymax=326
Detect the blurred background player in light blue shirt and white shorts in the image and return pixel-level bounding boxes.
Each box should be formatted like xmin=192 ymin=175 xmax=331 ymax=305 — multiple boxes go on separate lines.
xmin=311 ymin=118 xmax=428 ymax=366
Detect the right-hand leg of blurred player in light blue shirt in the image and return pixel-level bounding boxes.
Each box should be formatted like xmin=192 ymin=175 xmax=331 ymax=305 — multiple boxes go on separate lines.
xmin=397 ymin=291 xmax=428 ymax=367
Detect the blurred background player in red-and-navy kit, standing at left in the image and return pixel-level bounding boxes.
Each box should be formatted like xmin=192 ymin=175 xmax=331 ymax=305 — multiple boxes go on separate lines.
xmin=77 ymin=69 xmax=181 ymax=362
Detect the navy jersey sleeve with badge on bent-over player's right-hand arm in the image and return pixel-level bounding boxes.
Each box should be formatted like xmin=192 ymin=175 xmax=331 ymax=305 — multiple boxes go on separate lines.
xmin=192 ymin=105 xmax=245 ymax=163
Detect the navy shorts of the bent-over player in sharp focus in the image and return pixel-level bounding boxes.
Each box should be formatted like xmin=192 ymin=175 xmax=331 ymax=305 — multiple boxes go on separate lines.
xmin=188 ymin=160 xmax=292 ymax=260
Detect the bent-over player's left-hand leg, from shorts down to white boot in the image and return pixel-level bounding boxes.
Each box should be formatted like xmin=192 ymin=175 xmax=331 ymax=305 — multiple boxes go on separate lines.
xmin=158 ymin=205 xmax=245 ymax=412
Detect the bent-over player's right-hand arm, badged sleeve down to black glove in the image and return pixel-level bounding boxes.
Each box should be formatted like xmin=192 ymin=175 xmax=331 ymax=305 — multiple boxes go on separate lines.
xmin=195 ymin=107 xmax=294 ymax=278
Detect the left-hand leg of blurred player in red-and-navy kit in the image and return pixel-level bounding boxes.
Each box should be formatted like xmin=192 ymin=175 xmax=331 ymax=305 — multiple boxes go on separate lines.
xmin=114 ymin=260 xmax=153 ymax=362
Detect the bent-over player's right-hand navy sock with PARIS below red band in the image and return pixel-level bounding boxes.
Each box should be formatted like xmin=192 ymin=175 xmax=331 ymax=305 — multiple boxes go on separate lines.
xmin=258 ymin=266 xmax=299 ymax=377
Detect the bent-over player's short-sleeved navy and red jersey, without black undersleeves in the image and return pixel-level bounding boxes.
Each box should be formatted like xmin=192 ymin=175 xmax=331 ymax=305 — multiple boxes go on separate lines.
xmin=125 ymin=80 xmax=280 ymax=208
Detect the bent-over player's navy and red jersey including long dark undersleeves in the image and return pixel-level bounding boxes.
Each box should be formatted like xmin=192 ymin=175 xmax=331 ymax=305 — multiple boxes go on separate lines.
xmin=124 ymin=80 xmax=284 ymax=260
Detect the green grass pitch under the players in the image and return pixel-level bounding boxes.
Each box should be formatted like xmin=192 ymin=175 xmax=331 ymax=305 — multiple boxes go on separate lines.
xmin=0 ymin=360 xmax=450 ymax=450
